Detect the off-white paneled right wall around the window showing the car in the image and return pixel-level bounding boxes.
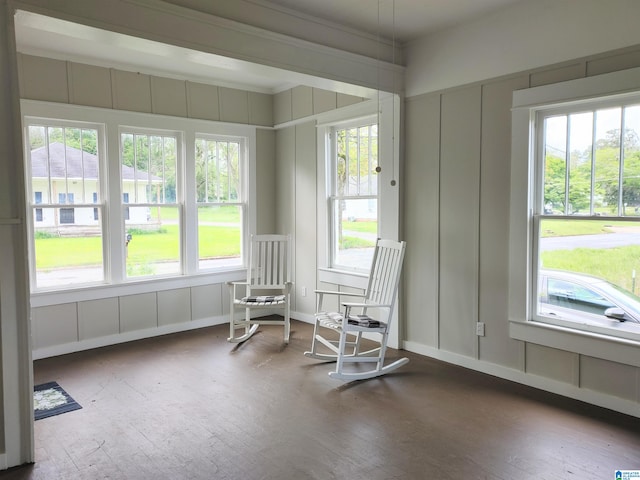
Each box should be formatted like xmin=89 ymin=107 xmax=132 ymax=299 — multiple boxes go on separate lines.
xmin=403 ymin=46 xmax=640 ymax=416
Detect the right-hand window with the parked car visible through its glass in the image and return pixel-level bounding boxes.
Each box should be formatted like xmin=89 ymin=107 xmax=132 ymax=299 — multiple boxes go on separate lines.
xmin=532 ymin=97 xmax=640 ymax=338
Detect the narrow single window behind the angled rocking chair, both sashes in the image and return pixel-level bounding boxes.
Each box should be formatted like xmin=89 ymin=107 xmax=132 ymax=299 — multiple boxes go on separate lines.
xmin=328 ymin=119 xmax=378 ymax=271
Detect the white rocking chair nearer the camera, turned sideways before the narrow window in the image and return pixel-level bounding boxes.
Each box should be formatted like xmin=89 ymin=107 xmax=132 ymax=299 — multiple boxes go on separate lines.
xmin=304 ymin=239 xmax=409 ymax=380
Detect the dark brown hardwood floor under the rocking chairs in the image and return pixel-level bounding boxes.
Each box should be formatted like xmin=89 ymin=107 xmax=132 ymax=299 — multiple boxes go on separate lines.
xmin=0 ymin=322 xmax=640 ymax=480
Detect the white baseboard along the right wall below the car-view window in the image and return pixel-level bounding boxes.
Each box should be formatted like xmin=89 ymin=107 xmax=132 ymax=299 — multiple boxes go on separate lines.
xmin=403 ymin=342 xmax=640 ymax=418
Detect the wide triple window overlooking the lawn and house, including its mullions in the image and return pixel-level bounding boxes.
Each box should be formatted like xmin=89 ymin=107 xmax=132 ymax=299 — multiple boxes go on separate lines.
xmin=23 ymin=101 xmax=255 ymax=292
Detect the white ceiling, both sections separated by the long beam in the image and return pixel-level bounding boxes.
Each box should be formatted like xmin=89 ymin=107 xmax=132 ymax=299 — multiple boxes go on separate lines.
xmin=15 ymin=0 xmax=531 ymax=93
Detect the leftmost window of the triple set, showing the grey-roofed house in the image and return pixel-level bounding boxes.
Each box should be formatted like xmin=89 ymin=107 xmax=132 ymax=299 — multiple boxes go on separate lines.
xmin=25 ymin=124 xmax=105 ymax=288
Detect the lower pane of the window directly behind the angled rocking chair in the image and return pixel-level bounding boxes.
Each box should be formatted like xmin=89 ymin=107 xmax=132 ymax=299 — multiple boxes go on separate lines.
xmin=333 ymin=198 xmax=378 ymax=268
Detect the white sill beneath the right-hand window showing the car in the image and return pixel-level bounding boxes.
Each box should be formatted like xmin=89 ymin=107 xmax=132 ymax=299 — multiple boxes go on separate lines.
xmin=509 ymin=321 xmax=640 ymax=367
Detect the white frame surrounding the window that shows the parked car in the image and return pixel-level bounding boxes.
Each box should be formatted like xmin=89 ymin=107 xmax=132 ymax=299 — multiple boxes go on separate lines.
xmin=509 ymin=68 xmax=640 ymax=366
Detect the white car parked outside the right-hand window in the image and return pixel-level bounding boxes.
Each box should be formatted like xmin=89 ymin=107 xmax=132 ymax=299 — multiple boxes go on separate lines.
xmin=538 ymin=269 xmax=640 ymax=323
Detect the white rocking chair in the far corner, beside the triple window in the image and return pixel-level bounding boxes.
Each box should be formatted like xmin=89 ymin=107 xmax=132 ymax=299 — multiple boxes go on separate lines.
xmin=227 ymin=235 xmax=292 ymax=343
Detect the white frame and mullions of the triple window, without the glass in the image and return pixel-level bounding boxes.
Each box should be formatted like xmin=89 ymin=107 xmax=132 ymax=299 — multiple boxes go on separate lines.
xmin=21 ymin=100 xmax=256 ymax=306
